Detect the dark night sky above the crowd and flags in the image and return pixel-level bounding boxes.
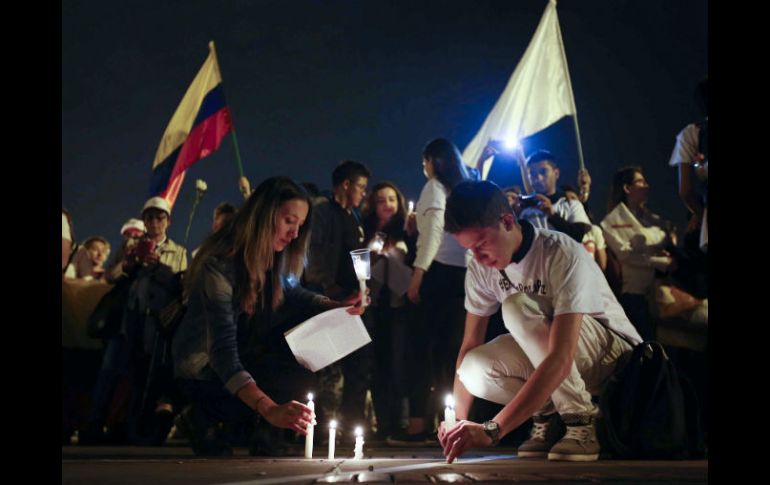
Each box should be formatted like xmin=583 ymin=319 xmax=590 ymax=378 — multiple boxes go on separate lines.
xmin=61 ymin=0 xmax=708 ymax=255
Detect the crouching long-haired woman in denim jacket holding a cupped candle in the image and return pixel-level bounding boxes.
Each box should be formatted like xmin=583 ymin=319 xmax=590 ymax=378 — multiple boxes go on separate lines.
xmin=172 ymin=177 xmax=362 ymax=455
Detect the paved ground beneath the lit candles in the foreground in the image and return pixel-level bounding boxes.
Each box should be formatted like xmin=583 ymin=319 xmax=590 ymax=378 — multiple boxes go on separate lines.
xmin=62 ymin=444 xmax=708 ymax=485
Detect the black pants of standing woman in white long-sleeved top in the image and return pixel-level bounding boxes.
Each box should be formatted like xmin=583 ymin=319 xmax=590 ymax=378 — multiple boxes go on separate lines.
xmin=409 ymin=261 xmax=466 ymax=419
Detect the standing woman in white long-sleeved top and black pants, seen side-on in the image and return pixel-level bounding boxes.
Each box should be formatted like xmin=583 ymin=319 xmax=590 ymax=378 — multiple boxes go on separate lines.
xmin=387 ymin=138 xmax=469 ymax=446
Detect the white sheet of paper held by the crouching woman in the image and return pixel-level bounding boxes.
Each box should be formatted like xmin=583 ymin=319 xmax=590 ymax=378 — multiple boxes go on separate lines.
xmin=284 ymin=308 xmax=372 ymax=372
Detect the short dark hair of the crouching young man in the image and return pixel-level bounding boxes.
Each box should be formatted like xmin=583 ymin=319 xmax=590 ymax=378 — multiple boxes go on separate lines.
xmin=444 ymin=180 xmax=515 ymax=234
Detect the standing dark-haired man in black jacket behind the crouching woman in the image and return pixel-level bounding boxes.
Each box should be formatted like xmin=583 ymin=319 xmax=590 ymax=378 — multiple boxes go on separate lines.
xmin=304 ymin=160 xmax=373 ymax=438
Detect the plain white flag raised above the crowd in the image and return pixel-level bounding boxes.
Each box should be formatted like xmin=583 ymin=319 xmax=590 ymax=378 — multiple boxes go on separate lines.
xmin=463 ymin=0 xmax=577 ymax=174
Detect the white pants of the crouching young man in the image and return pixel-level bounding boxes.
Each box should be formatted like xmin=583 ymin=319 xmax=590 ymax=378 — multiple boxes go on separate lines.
xmin=457 ymin=293 xmax=631 ymax=416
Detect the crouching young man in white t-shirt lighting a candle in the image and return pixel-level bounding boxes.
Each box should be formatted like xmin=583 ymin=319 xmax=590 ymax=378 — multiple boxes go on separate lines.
xmin=432 ymin=181 xmax=642 ymax=463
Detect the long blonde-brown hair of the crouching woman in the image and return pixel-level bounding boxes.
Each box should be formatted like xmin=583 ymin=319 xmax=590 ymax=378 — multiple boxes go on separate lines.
xmin=185 ymin=177 xmax=313 ymax=315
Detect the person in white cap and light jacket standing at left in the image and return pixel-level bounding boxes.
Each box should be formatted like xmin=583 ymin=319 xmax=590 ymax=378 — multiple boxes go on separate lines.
xmin=79 ymin=196 xmax=187 ymax=445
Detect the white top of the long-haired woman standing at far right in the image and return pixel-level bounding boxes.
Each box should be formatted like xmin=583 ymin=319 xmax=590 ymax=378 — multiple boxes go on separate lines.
xmin=602 ymin=202 xmax=671 ymax=295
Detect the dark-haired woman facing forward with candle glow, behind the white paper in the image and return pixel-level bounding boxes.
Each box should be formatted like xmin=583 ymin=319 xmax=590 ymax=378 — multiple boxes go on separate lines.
xmin=362 ymin=182 xmax=416 ymax=439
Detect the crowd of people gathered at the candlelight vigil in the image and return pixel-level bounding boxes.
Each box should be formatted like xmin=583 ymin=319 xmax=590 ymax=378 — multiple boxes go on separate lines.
xmin=62 ymin=77 xmax=708 ymax=462
